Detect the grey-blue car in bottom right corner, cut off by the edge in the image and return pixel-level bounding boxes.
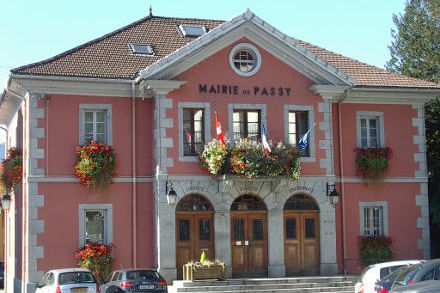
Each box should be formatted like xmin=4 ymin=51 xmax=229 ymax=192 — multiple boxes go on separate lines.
xmin=391 ymin=259 xmax=440 ymax=292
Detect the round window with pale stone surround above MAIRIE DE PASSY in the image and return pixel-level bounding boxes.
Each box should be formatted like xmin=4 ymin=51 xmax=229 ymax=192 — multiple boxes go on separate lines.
xmin=229 ymin=43 xmax=261 ymax=76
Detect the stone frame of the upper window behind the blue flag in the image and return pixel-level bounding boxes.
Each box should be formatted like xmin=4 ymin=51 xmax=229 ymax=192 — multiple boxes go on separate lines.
xmin=284 ymin=105 xmax=316 ymax=162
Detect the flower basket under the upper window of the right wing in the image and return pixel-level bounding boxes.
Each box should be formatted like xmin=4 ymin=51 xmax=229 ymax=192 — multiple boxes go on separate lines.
xmin=355 ymin=147 xmax=393 ymax=181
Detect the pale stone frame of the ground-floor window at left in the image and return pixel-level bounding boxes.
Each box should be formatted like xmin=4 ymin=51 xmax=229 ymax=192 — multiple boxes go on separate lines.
xmin=78 ymin=204 xmax=113 ymax=247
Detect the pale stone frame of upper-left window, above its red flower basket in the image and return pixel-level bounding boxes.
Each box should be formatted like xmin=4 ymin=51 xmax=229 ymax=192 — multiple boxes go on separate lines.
xmin=79 ymin=104 xmax=113 ymax=145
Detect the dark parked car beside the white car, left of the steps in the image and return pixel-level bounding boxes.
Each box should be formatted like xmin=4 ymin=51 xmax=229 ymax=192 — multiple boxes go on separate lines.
xmin=101 ymin=269 xmax=168 ymax=293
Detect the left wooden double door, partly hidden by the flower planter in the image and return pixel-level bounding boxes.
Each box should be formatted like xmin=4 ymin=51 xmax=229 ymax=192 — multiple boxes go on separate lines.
xmin=176 ymin=211 xmax=215 ymax=280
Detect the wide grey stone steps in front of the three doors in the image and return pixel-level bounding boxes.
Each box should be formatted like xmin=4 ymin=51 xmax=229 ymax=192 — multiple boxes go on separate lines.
xmin=168 ymin=276 xmax=358 ymax=293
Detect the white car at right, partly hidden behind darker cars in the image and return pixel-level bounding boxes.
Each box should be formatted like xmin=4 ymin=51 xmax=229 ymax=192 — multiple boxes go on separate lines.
xmin=354 ymin=260 xmax=420 ymax=293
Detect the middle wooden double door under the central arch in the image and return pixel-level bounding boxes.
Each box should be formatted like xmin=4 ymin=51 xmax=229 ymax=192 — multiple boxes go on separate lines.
xmin=231 ymin=211 xmax=267 ymax=278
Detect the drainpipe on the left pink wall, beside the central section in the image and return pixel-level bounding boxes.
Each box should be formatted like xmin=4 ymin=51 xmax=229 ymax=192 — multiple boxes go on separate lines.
xmin=131 ymin=80 xmax=137 ymax=268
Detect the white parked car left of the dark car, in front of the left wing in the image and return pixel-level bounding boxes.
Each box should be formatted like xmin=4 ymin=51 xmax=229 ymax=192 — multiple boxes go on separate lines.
xmin=35 ymin=268 xmax=100 ymax=293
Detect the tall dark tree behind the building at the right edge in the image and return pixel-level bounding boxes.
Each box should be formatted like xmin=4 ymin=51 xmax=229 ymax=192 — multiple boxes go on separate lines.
xmin=386 ymin=0 xmax=440 ymax=253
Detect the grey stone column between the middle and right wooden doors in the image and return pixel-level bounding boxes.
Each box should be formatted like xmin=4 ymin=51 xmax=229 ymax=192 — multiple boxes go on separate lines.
xmin=267 ymin=207 xmax=286 ymax=277
